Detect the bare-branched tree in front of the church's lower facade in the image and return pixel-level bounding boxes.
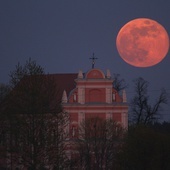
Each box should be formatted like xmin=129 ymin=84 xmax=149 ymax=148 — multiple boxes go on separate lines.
xmin=71 ymin=117 xmax=124 ymax=170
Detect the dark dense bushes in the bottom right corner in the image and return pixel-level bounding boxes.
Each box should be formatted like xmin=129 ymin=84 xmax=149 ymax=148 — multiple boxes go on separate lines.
xmin=119 ymin=125 xmax=170 ymax=170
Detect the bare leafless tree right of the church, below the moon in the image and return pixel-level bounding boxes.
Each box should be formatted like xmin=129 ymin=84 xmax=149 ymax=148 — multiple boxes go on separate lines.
xmin=130 ymin=77 xmax=167 ymax=124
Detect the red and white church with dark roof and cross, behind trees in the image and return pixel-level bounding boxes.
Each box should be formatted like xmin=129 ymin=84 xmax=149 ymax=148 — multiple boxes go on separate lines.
xmin=0 ymin=58 xmax=128 ymax=169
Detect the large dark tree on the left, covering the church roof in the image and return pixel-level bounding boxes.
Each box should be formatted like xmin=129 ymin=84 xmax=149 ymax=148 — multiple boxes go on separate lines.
xmin=1 ymin=59 xmax=68 ymax=170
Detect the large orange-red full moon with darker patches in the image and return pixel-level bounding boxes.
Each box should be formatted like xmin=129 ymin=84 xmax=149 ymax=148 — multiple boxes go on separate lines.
xmin=116 ymin=18 xmax=169 ymax=67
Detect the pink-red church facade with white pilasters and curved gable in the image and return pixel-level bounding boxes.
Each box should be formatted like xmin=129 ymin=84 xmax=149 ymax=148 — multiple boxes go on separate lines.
xmin=62 ymin=69 xmax=128 ymax=133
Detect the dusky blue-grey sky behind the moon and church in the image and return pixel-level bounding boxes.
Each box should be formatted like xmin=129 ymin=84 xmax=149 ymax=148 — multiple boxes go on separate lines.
xmin=0 ymin=0 xmax=170 ymax=121
